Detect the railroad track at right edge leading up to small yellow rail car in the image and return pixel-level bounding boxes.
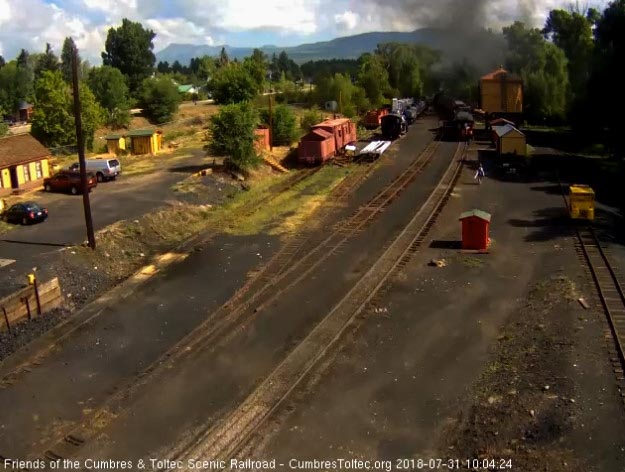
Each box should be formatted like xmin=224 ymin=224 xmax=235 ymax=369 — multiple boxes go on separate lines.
xmin=577 ymin=224 xmax=625 ymax=390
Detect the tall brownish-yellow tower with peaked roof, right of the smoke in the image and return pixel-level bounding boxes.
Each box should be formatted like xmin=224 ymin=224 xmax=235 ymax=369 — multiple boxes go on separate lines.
xmin=480 ymin=69 xmax=523 ymax=114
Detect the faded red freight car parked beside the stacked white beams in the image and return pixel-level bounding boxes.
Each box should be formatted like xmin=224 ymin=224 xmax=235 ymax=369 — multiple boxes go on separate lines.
xmin=297 ymin=118 xmax=358 ymax=164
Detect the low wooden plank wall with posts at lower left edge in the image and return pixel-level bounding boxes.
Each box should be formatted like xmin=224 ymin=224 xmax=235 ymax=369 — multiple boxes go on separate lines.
xmin=0 ymin=277 xmax=63 ymax=331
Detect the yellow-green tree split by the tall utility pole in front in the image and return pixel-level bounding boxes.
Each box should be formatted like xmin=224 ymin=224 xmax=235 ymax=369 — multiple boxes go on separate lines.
xmin=31 ymin=71 xmax=103 ymax=149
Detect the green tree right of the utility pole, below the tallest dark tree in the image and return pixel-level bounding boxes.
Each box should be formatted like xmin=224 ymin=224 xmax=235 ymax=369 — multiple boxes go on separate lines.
xmin=88 ymin=66 xmax=130 ymax=128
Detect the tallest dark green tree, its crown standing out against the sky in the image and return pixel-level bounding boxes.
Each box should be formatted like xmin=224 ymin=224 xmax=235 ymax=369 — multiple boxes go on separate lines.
xmin=102 ymin=18 xmax=156 ymax=94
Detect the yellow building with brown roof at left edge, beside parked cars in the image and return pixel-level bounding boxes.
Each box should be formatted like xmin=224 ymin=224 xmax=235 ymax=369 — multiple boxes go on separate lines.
xmin=0 ymin=134 xmax=50 ymax=195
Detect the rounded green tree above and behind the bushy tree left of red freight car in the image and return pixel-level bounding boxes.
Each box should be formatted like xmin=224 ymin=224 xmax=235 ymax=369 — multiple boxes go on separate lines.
xmin=209 ymin=62 xmax=259 ymax=104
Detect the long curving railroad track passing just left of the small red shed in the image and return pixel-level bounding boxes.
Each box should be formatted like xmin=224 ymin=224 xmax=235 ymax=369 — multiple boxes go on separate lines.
xmin=165 ymin=144 xmax=466 ymax=470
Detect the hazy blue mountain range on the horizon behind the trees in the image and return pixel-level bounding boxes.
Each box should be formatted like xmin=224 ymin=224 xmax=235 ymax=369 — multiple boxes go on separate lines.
xmin=156 ymin=28 xmax=504 ymax=69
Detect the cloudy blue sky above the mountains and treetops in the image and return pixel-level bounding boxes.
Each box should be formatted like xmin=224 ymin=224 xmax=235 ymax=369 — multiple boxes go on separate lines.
xmin=0 ymin=0 xmax=607 ymax=64
